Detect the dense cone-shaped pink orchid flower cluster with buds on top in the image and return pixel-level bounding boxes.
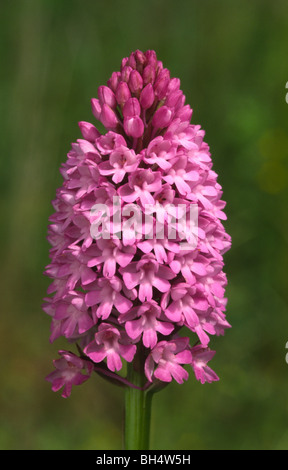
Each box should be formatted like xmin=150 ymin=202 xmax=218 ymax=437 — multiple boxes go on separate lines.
xmin=43 ymin=50 xmax=231 ymax=397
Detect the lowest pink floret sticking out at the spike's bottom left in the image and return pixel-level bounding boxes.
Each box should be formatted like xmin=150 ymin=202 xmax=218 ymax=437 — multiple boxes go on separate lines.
xmin=46 ymin=351 xmax=93 ymax=398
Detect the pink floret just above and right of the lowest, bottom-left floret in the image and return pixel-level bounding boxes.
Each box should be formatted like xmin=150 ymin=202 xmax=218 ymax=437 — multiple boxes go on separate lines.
xmin=84 ymin=323 xmax=136 ymax=371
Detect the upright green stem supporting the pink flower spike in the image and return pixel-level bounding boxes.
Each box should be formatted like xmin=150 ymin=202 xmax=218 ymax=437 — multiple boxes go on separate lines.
xmin=124 ymin=360 xmax=153 ymax=450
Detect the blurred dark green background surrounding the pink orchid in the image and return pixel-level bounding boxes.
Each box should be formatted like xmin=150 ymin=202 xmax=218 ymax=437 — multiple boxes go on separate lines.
xmin=0 ymin=0 xmax=288 ymax=450
